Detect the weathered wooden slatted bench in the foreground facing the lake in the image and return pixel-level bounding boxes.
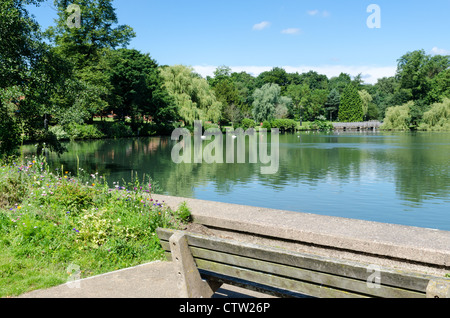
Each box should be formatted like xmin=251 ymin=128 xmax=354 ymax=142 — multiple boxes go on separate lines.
xmin=157 ymin=228 xmax=450 ymax=298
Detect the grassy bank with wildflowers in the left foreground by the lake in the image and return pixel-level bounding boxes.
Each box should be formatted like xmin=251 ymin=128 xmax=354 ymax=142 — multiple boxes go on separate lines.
xmin=0 ymin=158 xmax=190 ymax=297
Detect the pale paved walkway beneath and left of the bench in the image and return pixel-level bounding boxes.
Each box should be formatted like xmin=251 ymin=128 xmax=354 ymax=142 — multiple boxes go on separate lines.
xmin=19 ymin=261 xmax=267 ymax=298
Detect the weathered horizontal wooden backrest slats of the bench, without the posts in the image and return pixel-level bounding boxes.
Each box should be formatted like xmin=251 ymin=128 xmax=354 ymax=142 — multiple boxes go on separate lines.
xmin=157 ymin=229 xmax=446 ymax=298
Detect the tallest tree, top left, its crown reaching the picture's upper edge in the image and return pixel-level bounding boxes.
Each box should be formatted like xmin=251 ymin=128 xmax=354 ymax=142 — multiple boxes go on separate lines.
xmin=46 ymin=0 xmax=135 ymax=122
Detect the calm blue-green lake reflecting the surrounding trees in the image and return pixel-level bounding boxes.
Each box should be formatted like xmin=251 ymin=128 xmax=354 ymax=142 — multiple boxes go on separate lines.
xmin=24 ymin=132 xmax=450 ymax=231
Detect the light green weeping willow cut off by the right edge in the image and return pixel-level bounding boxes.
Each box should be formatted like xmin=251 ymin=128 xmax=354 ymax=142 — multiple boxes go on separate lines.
xmin=419 ymin=98 xmax=450 ymax=131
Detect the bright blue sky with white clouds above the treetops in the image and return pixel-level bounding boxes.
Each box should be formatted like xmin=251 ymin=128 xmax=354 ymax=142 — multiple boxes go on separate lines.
xmin=30 ymin=0 xmax=450 ymax=83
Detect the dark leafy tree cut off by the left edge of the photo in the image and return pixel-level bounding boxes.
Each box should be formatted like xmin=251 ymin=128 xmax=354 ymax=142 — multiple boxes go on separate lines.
xmin=0 ymin=0 xmax=67 ymax=154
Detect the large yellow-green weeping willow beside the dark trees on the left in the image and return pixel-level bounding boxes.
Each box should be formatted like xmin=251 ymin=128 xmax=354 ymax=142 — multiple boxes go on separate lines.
xmin=160 ymin=65 xmax=222 ymax=125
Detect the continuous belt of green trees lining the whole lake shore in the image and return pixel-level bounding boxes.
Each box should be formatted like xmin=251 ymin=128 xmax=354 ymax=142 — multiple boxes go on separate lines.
xmin=0 ymin=0 xmax=450 ymax=157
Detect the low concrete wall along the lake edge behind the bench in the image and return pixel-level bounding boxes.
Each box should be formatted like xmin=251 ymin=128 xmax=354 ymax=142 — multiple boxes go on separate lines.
xmin=152 ymin=195 xmax=450 ymax=275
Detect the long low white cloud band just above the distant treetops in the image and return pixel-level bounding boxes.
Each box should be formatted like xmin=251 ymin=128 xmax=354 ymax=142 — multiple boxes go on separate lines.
xmin=193 ymin=65 xmax=397 ymax=84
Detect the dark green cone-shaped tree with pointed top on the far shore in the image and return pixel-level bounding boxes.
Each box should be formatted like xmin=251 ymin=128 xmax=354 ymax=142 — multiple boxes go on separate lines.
xmin=339 ymin=84 xmax=363 ymax=122
